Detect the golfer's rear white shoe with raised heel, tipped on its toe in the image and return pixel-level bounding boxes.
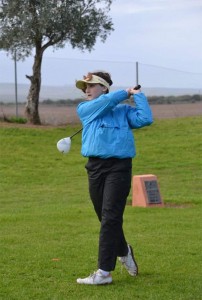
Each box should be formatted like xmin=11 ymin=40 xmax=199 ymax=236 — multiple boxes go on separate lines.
xmin=118 ymin=245 xmax=138 ymax=276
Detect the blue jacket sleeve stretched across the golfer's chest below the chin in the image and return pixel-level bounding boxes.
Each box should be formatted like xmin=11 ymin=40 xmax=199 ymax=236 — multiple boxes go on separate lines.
xmin=77 ymin=90 xmax=128 ymax=125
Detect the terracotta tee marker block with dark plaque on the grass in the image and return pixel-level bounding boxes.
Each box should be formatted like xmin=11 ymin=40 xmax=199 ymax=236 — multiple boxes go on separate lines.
xmin=132 ymin=174 xmax=164 ymax=207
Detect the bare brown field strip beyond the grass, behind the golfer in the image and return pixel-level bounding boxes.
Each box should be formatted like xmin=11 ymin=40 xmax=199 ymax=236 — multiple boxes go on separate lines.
xmin=0 ymin=102 xmax=202 ymax=126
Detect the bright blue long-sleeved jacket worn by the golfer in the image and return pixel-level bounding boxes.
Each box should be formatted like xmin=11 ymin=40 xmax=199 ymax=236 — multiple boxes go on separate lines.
xmin=77 ymin=90 xmax=153 ymax=158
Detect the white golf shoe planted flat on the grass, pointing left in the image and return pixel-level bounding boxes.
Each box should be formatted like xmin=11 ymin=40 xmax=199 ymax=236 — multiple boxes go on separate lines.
xmin=77 ymin=270 xmax=112 ymax=285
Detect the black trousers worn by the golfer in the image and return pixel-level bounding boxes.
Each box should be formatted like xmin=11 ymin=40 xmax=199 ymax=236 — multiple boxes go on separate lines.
xmin=86 ymin=157 xmax=132 ymax=271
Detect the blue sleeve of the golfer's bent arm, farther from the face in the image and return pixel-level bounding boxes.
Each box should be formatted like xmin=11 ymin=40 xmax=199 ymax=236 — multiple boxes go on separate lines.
xmin=127 ymin=93 xmax=153 ymax=128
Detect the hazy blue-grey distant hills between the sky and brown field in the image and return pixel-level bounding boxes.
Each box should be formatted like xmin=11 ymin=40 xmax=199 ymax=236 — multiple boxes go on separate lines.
xmin=0 ymin=83 xmax=200 ymax=103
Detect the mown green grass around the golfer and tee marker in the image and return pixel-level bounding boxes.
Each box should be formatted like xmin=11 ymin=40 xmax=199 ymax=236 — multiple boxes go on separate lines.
xmin=0 ymin=117 xmax=202 ymax=300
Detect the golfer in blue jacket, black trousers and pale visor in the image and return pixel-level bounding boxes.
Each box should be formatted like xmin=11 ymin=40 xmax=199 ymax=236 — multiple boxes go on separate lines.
xmin=76 ymin=72 xmax=153 ymax=285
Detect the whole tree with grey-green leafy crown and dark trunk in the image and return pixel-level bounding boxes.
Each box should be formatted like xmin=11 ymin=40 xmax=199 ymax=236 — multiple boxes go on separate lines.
xmin=0 ymin=0 xmax=113 ymax=124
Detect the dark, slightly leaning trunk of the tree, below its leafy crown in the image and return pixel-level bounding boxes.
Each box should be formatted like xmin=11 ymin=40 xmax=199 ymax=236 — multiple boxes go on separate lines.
xmin=25 ymin=50 xmax=43 ymax=125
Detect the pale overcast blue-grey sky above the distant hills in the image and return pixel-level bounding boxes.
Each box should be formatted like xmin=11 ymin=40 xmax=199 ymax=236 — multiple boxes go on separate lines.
xmin=0 ymin=0 xmax=202 ymax=88
